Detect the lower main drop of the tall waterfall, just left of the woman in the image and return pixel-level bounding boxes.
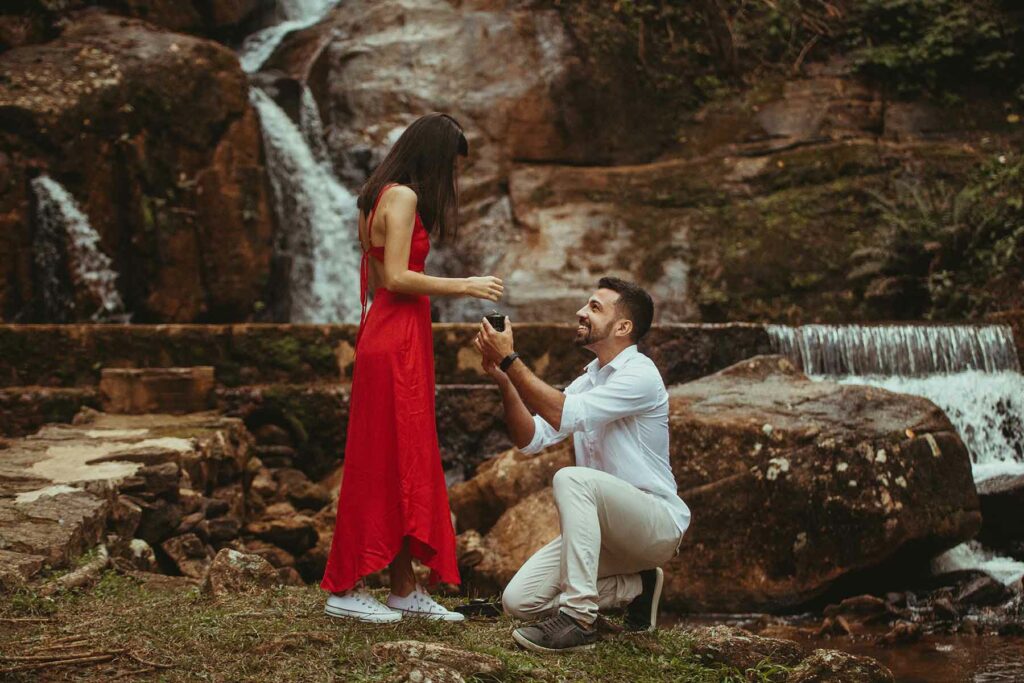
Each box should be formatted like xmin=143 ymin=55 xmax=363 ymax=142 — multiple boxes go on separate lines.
xmin=249 ymin=88 xmax=360 ymax=323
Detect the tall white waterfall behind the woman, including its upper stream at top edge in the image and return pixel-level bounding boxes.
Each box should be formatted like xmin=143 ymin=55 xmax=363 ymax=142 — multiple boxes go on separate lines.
xmin=240 ymin=0 xmax=360 ymax=323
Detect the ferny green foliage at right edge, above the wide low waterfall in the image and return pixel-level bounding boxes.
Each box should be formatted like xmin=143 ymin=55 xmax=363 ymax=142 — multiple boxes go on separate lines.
xmin=874 ymin=154 xmax=1024 ymax=319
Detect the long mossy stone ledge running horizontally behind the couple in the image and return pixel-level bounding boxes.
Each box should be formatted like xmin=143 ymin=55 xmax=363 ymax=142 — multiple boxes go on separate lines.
xmin=0 ymin=323 xmax=770 ymax=387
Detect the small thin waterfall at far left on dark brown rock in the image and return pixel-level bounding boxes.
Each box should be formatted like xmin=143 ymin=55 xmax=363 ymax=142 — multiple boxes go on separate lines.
xmin=32 ymin=175 xmax=125 ymax=322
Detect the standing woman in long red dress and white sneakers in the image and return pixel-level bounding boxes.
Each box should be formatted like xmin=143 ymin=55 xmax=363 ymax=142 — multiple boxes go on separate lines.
xmin=321 ymin=114 xmax=503 ymax=623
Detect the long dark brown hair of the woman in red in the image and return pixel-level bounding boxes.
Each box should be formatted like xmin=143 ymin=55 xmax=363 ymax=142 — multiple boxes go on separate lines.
xmin=357 ymin=113 xmax=469 ymax=241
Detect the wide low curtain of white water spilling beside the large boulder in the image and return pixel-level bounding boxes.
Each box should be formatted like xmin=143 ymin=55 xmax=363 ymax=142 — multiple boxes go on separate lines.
xmin=768 ymin=325 xmax=1024 ymax=584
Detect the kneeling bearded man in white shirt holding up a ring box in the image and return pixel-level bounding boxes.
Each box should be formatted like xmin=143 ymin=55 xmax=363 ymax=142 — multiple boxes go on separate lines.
xmin=475 ymin=278 xmax=690 ymax=652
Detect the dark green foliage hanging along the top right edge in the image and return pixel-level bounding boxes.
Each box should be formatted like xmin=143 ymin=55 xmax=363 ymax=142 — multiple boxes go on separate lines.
xmin=542 ymin=0 xmax=1024 ymax=112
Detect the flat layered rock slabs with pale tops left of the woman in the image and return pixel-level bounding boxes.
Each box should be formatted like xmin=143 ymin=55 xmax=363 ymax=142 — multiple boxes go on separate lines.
xmin=0 ymin=414 xmax=252 ymax=577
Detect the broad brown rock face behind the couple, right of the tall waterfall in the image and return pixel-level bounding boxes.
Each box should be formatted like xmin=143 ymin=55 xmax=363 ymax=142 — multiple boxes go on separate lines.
xmin=256 ymin=0 xmax=980 ymax=322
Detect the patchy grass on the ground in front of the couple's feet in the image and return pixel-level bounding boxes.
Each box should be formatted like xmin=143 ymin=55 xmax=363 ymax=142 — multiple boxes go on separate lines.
xmin=0 ymin=571 xmax=786 ymax=683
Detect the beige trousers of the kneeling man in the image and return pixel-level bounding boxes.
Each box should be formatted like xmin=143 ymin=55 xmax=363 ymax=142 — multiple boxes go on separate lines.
xmin=502 ymin=467 xmax=682 ymax=624
